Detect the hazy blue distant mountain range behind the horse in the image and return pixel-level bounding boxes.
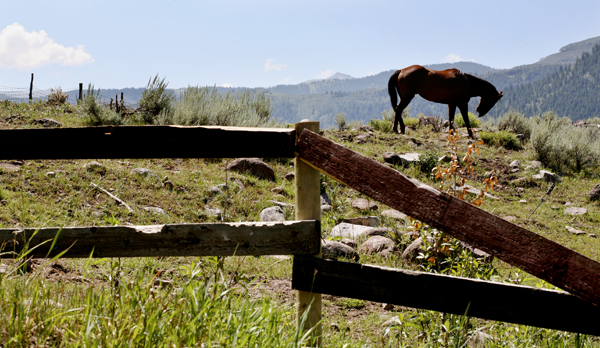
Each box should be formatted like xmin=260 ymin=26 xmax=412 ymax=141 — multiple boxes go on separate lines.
xmin=62 ymin=36 xmax=600 ymax=128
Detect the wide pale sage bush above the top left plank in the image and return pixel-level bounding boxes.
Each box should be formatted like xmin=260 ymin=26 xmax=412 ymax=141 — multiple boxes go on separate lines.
xmin=158 ymin=87 xmax=280 ymax=127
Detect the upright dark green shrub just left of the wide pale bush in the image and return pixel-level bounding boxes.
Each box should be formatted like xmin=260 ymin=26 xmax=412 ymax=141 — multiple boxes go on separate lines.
xmin=138 ymin=75 xmax=175 ymax=124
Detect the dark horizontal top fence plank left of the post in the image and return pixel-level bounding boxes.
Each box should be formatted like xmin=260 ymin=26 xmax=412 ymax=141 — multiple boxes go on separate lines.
xmin=0 ymin=126 xmax=295 ymax=160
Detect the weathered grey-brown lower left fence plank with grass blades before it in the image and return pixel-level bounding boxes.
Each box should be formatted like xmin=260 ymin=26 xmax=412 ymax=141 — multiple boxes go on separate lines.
xmin=0 ymin=221 xmax=321 ymax=258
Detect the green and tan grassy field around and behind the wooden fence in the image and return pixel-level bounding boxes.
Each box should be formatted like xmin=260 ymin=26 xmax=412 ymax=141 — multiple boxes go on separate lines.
xmin=0 ymin=103 xmax=600 ymax=347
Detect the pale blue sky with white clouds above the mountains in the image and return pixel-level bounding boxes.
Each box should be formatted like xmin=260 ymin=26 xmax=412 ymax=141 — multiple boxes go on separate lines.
xmin=0 ymin=0 xmax=600 ymax=90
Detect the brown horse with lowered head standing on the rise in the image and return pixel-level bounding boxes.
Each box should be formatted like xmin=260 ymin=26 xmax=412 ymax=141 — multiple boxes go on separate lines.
xmin=388 ymin=65 xmax=502 ymax=138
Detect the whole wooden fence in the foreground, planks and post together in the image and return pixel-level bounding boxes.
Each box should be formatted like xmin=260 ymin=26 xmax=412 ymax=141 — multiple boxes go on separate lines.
xmin=0 ymin=122 xmax=600 ymax=342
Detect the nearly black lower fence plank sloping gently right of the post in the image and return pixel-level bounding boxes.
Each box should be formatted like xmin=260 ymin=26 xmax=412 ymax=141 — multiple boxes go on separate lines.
xmin=292 ymin=256 xmax=600 ymax=336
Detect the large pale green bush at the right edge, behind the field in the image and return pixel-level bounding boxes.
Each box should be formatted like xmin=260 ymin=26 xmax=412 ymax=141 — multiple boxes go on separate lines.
xmin=531 ymin=112 xmax=600 ymax=172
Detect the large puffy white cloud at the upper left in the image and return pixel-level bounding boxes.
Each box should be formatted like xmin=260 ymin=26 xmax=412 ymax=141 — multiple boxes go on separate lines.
xmin=0 ymin=22 xmax=94 ymax=70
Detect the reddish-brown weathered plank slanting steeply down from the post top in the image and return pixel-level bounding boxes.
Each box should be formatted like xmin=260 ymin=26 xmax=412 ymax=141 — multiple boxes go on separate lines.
xmin=297 ymin=130 xmax=600 ymax=306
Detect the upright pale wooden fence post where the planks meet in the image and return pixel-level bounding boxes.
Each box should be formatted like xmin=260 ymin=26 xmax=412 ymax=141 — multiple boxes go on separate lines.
xmin=294 ymin=121 xmax=322 ymax=346
